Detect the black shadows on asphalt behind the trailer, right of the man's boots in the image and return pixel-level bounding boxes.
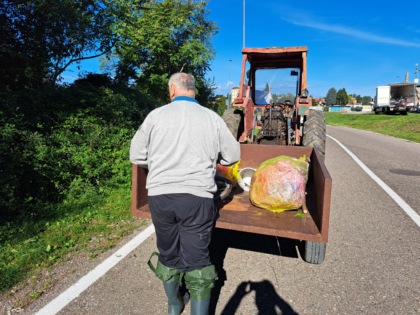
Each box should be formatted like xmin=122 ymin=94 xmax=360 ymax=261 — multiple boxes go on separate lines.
xmin=210 ymin=228 xmax=300 ymax=315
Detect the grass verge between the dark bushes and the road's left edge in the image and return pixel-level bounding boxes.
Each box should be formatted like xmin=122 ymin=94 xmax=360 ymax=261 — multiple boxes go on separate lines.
xmin=0 ymin=185 xmax=142 ymax=299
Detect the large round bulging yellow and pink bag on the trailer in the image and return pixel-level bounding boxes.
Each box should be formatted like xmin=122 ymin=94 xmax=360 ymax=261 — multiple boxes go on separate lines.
xmin=249 ymin=155 xmax=309 ymax=212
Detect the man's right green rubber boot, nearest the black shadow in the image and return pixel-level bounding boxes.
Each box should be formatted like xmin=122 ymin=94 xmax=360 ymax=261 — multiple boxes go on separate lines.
xmin=185 ymin=265 xmax=217 ymax=315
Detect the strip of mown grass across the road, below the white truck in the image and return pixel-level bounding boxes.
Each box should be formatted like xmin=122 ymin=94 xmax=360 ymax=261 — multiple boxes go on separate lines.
xmin=325 ymin=112 xmax=420 ymax=143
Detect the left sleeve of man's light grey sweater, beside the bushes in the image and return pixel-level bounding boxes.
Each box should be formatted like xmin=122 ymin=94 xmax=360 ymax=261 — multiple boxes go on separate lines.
xmin=130 ymin=117 xmax=150 ymax=168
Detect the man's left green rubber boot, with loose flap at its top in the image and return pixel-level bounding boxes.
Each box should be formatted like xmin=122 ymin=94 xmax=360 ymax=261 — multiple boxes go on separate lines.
xmin=148 ymin=254 xmax=185 ymax=315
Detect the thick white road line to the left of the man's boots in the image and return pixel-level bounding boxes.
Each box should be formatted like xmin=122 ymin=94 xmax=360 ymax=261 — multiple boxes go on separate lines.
xmin=36 ymin=224 xmax=155 ymax=315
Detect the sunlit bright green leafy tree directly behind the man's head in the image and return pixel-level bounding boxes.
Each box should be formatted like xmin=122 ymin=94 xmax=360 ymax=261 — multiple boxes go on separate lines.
xmin=108 ymin=0 xmax=217 ymax=106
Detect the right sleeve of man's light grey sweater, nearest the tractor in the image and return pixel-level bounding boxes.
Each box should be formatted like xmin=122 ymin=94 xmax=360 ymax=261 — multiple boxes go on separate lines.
xmin=218 ymin=118 xmax=241 ymax=166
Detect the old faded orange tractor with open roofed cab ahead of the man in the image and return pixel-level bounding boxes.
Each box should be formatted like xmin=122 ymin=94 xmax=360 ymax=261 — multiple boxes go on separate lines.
xmin=223 ymin=47 xmax=326 ymax=155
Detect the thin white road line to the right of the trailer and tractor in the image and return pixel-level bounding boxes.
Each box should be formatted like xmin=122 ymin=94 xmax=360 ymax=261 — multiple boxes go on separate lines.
xmin=327 ymin=135 xmax=420 ymax=227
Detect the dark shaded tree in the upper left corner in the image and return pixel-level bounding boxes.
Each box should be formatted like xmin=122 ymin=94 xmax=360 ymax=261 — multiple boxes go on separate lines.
xmin=0 ymin=0 xmax=114 ymax=89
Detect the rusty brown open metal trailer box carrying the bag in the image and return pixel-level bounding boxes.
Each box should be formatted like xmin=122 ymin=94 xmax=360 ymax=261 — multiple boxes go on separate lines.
xmin=132 ymin=144 xmax=332 ymax=264
